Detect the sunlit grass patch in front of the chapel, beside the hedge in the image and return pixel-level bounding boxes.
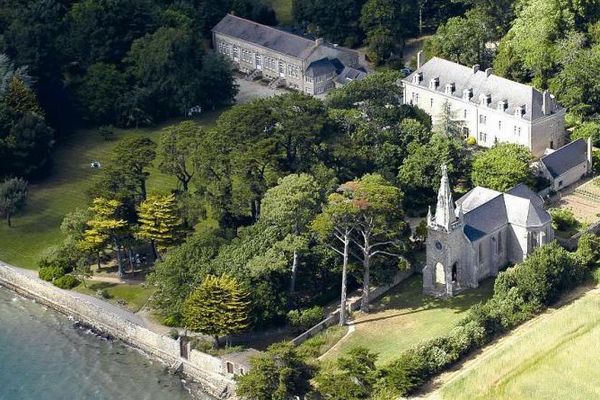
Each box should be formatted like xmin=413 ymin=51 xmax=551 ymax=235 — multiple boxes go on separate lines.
xmin=325 ymin=274 xmax=493 ymax=365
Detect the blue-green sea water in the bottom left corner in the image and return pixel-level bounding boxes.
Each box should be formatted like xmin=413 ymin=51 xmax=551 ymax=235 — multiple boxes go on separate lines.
xmin=0 ymin=287 xmax=210 ymax=400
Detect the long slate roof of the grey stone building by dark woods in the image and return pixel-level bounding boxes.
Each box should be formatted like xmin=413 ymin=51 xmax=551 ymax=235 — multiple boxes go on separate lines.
xmin=213 ymin=14 xmax=316 ymax=59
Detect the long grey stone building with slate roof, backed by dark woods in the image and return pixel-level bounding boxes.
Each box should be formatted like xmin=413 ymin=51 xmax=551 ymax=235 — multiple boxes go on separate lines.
xmin=212 ymin=14 xmax=366 ymax=95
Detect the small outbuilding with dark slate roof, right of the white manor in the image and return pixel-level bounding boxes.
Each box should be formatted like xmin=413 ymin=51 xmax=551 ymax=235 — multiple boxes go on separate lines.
xmin=538 ymin=139 xmax=592 ymax=191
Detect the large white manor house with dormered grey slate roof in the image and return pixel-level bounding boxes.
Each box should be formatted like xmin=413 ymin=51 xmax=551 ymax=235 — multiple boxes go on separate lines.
xmin=402 ymin=52 xmax=567 ymax=157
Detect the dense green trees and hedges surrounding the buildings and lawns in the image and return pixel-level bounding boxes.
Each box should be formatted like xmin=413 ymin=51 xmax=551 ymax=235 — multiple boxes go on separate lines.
xmin=0 ymin=0 xmax=600 ymax=399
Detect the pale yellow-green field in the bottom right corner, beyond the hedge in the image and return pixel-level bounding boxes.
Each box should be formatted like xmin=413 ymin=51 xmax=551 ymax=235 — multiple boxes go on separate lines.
xmin=440 ymin=290 xmax=600 ymax=400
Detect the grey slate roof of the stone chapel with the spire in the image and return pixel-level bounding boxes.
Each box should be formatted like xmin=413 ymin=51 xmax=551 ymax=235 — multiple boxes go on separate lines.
xmin=456 ymin=184 xmax=551 ymax=242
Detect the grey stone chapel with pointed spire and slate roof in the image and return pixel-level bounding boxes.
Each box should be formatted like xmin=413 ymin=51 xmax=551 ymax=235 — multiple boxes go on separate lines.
xmin=423 ymin=166 xmax=554 ymax=297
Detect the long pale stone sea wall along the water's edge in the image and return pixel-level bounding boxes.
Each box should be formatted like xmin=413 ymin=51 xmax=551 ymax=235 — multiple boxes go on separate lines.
xmin=0 ymin=262 xmax=235 ymax=399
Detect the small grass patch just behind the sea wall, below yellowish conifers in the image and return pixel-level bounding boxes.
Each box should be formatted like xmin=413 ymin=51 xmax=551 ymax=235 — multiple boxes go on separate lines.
xmin=74 ymin=282 xmax=152 ymax=312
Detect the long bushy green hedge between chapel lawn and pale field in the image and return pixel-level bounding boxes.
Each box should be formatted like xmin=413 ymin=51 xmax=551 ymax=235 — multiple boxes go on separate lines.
xmin=373 ymin=234 xmax=600 ymax=399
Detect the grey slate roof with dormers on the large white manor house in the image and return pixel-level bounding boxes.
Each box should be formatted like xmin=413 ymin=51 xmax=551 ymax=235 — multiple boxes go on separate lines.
xmin=403 ymin=57 xmax=562 ymax=121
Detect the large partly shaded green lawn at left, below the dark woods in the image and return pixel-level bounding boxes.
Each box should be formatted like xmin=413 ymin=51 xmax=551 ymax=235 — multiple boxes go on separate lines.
xmin=0 ymin=112 xmax=220 ymax=269
